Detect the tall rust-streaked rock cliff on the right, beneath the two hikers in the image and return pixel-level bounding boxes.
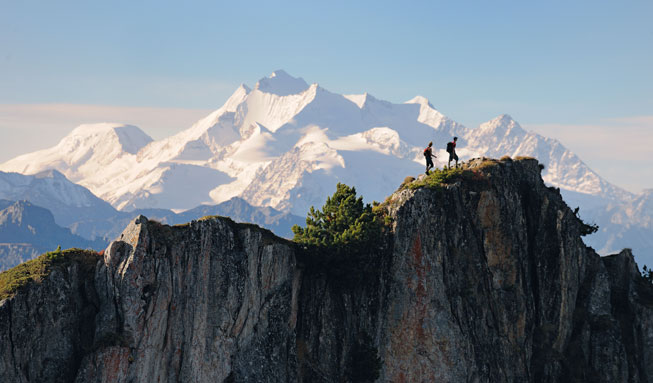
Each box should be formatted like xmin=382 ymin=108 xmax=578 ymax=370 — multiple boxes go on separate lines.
xmin=297 ymin=160 xmax=653 ymax=382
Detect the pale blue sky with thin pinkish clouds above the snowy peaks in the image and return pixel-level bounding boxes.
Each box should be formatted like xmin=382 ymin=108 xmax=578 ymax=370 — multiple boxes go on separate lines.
xmin=0 ymin=0 xmax=653 ymax=192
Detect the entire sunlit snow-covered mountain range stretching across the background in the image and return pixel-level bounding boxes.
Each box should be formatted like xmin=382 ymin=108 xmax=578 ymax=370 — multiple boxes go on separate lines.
xmin=0 ymin=71 xmax=653 ymax=265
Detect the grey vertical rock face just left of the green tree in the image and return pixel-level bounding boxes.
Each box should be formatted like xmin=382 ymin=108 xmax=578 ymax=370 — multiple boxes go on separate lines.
xmin=77 ymin=217 xmax=297 ymax=382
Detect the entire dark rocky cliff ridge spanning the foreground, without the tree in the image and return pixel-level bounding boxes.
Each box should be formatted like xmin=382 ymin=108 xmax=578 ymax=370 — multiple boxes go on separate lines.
xmin=0 ymin=158 xmax=653 ymax=383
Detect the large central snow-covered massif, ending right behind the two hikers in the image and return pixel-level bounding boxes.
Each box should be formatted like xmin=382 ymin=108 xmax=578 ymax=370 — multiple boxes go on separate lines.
xmin=0 ymin=71 xmax=466 ymax=215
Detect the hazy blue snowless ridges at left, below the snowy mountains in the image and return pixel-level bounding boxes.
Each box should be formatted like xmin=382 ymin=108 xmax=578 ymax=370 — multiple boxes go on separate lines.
xmin=0 ymin=170 xmax=304 ymax=271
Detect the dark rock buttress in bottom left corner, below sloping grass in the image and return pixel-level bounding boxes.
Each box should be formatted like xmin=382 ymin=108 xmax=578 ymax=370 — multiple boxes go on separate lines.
xmin=0 ymin=254 xmax=98 ymax=383
